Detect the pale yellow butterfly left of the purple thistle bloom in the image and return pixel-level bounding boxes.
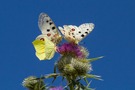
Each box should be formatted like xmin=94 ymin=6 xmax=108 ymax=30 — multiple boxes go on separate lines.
xmin=32 ymin=37 xmax=55 ymax=60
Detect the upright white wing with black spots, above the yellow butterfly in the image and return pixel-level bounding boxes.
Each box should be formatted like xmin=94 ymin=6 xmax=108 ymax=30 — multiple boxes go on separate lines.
xmin=38 ymin=13 xmax=62 ymax=44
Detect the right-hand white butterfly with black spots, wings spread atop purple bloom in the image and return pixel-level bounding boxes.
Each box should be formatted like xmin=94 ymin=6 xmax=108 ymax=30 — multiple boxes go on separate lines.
xmin=58 ymin=23 xmax=94 ymax=43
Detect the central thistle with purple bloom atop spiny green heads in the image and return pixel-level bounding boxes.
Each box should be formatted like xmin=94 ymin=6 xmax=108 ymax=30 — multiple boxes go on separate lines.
xmin=56 ymin=43 xmax=99 ymax=90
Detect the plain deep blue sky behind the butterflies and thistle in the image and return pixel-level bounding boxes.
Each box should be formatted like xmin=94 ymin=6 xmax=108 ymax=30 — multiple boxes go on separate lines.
xmin=0 ymin=0 xmax=135 ymax=90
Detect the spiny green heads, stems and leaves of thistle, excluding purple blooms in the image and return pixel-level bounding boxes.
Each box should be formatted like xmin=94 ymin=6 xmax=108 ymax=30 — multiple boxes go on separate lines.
xmin=23 ymin=56 xmax=103 ymax=90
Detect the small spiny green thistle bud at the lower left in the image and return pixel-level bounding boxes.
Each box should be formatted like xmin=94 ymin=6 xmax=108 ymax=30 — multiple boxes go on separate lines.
xmin=22 ymin=76 xmax=46 ymax=90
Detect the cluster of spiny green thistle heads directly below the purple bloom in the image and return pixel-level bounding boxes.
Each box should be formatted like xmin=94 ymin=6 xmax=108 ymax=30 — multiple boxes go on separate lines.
xmin=57 ymin=55 xmax=92 ymax=77
